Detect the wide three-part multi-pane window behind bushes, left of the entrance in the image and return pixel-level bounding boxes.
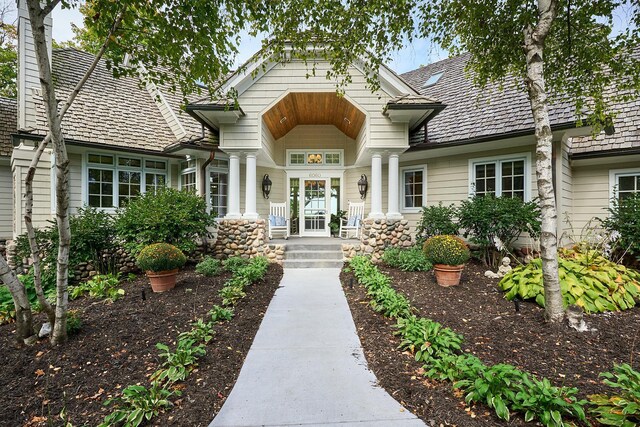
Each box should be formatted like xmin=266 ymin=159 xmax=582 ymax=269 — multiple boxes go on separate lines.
xmin=86 ymin=153 xmax=167 ymax=208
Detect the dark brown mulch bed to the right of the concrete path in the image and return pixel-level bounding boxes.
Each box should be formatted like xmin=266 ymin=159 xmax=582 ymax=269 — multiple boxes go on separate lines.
xmin=341 ymin=262 xmax=640 ymax=427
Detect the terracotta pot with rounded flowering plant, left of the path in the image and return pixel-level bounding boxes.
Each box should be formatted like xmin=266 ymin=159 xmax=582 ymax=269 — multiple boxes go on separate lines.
xmin=136 ymin=243 xmax=187 ymax=292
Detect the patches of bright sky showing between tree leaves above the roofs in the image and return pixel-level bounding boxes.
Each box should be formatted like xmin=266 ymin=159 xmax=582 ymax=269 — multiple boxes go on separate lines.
xmin=4 ymin=0 xmax=448 ymax=73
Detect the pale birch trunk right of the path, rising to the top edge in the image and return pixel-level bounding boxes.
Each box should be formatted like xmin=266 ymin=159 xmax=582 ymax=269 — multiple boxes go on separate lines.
xmin=524 ymin=0 xmax=564 ymax=323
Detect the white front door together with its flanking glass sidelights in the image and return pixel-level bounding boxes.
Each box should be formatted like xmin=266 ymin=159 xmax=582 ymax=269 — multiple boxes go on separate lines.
xmin=289 ymin=173 xmax=342 ymax=237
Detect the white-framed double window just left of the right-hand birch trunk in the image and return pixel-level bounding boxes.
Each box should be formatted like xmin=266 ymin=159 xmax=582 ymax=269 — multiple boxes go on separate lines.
xmin=471 ymin=159 xmax=527 ymax=200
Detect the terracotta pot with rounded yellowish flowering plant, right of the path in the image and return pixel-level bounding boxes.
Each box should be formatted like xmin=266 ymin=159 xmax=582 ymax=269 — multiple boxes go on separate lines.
xmin=423 ymin=235 xmax=471 ymax=286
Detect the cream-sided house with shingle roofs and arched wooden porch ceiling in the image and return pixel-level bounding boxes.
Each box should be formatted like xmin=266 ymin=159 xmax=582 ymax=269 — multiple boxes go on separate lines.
xmin=5 ymin=1 xmax=640 ymax=260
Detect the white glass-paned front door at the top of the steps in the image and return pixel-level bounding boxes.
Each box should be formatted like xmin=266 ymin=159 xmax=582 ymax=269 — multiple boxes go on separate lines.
xmin=300 ymin=178 xmax=329 ymax=236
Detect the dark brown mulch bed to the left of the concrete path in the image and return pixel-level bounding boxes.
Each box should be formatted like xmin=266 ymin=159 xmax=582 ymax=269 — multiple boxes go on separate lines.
xmin=0 ymin=265 xmax=282 ymax=426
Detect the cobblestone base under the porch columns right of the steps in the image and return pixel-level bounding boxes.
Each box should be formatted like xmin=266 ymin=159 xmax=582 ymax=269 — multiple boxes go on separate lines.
xmin=342 ymin=219 xmax=413 ymax=262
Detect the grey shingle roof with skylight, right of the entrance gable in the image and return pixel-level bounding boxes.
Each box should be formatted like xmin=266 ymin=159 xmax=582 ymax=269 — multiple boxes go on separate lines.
xmin=402 ymin=54 xmax=575 ymax=146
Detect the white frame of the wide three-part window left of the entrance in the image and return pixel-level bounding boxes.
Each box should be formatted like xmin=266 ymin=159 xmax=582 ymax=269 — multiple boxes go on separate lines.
xmin=82 ymin=151 xmax=170 ymax=212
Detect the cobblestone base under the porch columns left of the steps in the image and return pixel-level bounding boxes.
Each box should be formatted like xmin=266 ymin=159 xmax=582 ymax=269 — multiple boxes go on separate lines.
xmin=214 ymin=219 xmax=284 ymax=264
